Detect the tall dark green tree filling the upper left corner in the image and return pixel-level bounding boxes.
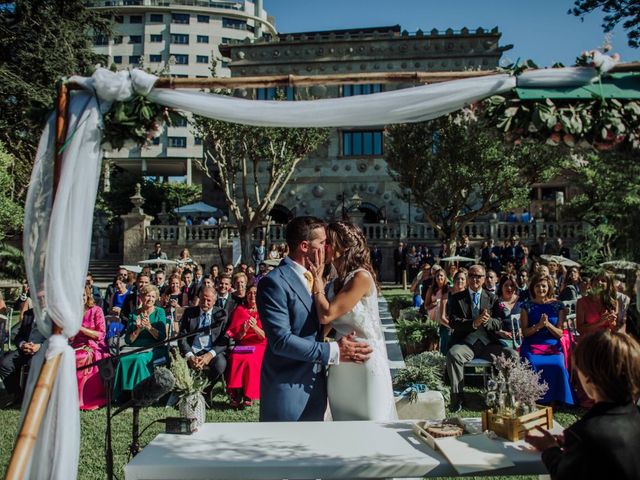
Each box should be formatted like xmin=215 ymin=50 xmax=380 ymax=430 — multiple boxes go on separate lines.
xmin=0 ymin=0 xmax=110 ymax=203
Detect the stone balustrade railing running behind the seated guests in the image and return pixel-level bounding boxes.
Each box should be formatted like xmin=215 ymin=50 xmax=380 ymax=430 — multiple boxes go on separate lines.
xmin=145 ymin=220 xmax=584 ymax=246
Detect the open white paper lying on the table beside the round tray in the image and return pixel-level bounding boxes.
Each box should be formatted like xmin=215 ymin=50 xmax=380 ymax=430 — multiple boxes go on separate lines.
xmin=435 ymin=433 xmax=515 ymax=475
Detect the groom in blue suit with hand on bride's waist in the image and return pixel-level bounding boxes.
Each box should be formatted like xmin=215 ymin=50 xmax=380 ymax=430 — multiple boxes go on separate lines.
xmin=257 ymin=217 xmax=372 ymax=422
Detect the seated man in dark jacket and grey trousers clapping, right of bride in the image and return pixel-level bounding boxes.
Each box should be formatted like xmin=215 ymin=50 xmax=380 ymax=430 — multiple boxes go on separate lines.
xmin=447 ymin=265 xmax=517 ymax=412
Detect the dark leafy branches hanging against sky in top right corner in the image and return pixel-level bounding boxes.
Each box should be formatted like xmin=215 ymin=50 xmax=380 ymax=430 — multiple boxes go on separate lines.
xmin=567 ymin=0 xmax=640 ymax=48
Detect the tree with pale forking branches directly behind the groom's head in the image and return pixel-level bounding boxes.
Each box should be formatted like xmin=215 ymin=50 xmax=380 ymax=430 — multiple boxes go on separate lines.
xmin=194 ymin=111 xmax=328 ymax=262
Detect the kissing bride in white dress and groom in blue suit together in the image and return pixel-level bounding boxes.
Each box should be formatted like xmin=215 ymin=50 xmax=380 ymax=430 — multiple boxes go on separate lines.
xmin=257 ymin=217 xmax=397 ymax=422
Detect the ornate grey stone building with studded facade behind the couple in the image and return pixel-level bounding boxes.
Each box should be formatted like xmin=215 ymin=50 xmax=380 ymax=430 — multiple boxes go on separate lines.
xmin=216 ymin=25 xmax=510 ymax=227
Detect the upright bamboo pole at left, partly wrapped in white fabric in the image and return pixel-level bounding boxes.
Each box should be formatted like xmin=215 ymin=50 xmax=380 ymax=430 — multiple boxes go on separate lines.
xmin=5 ymin=84 xmax=69 ymax=480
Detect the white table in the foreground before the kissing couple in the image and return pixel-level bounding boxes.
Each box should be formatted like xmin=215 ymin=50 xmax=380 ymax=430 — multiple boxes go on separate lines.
xmin=125 ymin=421 xmax=560 ymax=480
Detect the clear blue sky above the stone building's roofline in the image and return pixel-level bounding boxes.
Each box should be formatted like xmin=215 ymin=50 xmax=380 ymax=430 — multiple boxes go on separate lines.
xmin=263 ymin=0 xmax=640 ymax=67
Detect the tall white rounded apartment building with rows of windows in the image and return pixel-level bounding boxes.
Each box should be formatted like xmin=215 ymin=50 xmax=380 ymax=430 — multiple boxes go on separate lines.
xmin=89 ymin=0 xmax=276 ymax=183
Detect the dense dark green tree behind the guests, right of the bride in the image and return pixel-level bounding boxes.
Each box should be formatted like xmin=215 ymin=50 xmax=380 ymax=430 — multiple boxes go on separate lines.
xmin=385 ymin=109 xmax=560 ymax=255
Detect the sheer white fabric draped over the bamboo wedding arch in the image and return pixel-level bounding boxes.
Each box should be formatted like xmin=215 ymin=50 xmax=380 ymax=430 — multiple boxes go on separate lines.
xmin=18 ymin=63 xmax=596 ymax=480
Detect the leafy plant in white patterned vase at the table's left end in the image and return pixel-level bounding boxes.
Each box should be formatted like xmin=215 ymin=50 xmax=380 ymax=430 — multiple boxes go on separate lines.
xmin=170 ymin=350 xmax=210 ymax=426
